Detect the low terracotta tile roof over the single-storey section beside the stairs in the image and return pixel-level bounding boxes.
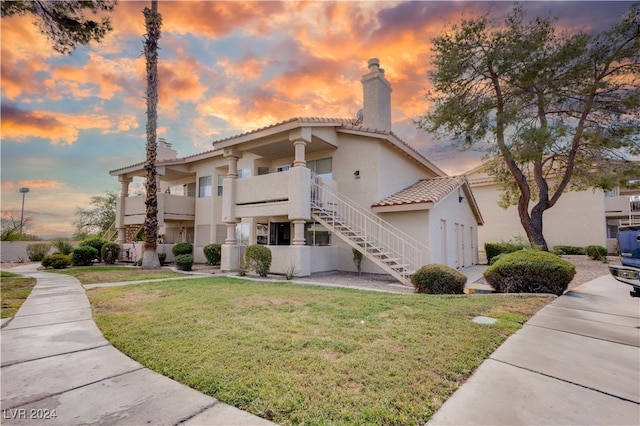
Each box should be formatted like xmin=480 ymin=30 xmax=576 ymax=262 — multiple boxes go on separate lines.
xmin=371 ymin=176 xmax=466 ymax=207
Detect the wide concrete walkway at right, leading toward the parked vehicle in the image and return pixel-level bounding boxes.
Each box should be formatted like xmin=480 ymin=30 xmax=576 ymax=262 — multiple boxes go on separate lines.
xmin=427 ymin=276 xmax=640 ymax=426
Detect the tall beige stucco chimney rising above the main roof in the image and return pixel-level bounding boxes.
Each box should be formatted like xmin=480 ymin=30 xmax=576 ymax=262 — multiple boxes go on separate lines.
xmin=361 ymin=58 xmax=391 ymax=131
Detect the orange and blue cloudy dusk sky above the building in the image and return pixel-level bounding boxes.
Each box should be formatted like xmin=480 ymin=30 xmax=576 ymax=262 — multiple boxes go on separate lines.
xmin=1 ymin=1 xmax=633 ymax=238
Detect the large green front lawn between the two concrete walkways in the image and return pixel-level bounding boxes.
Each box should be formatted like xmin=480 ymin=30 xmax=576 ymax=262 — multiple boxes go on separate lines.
xmin=88 ymin=277 xmax=551 ymax=425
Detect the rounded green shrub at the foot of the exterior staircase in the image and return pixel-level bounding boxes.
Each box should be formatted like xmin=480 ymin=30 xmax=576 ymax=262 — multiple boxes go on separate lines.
xmin=411 ymin=263 xmax=467 ymax=294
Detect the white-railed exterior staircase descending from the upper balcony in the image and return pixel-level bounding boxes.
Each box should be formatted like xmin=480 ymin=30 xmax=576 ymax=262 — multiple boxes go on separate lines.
xmin=311 ymin=180 xmax=430 ymax=285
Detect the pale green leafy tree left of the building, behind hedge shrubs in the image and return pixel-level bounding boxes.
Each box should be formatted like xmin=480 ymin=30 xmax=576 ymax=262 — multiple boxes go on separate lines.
xmin=73 ymin=192 xmax=118 ymax=240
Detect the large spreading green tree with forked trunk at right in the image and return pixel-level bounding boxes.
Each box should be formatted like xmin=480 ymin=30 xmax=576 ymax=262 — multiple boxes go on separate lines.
xmin=416 ymin=4 xmax=640 ymax=250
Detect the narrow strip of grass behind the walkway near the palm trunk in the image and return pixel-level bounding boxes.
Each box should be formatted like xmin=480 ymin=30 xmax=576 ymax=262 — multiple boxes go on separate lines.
xmin=47 ymin=266 xmax=181 ymax=284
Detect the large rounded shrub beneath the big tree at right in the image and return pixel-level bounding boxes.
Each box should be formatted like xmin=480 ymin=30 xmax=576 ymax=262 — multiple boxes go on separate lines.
xmin=484 ymin=250 xmax=576 ymax=296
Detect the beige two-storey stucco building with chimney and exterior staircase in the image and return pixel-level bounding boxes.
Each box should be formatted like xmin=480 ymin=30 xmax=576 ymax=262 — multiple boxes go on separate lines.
xmin=110 ymin=59 xmax=482 ymax=282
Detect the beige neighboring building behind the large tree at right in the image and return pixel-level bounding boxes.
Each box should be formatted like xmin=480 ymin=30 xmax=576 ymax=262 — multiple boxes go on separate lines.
xmin=465 ymin=165 xmax=640 ymax=260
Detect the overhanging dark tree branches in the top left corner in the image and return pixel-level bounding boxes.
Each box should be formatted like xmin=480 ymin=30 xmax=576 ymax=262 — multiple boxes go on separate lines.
xmin=1 ymin=0 xmax=117 ymax=55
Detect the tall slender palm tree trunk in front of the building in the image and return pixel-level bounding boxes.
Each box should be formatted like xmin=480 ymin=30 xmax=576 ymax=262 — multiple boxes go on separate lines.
xmin=142 ymin=0 xmax=162 ymax=269
